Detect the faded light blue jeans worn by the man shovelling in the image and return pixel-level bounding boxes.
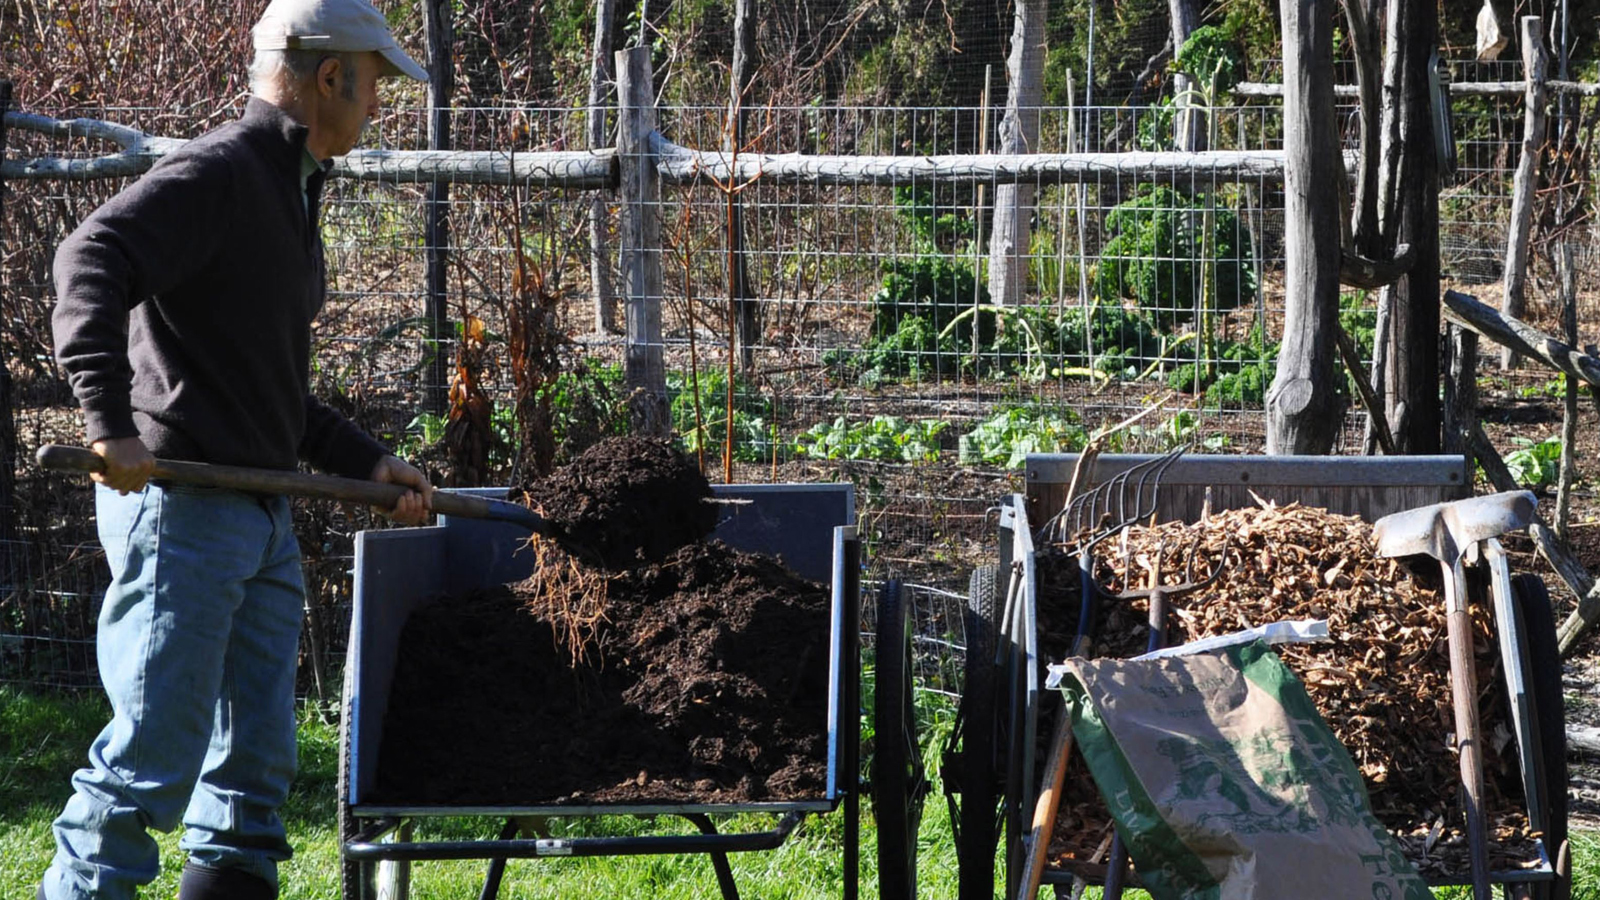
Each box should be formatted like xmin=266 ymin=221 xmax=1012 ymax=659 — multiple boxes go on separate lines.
xmin=43 ymin=485 xmax=306 ymax=900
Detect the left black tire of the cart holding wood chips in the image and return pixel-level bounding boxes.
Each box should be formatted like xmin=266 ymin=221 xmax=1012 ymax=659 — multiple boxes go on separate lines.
xmin=955 ymin=565 xmax=1002 ymax=900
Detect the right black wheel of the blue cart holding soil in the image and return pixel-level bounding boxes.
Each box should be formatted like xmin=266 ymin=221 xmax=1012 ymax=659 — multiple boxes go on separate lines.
xmin=872 ymin=581 xmax=928 ymax=900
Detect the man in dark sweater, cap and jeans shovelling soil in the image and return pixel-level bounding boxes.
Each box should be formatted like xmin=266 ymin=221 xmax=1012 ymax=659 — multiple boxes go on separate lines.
xmin=38 ymin=0 xmax=429 ymax=900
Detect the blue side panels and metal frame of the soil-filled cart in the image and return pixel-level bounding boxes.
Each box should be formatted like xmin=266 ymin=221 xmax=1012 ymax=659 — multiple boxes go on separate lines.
xmin=339 ymin=484 xmax=886 ymax=900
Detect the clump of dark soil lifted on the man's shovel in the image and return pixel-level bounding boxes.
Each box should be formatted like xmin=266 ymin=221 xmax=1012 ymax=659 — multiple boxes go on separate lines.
xmin=522 ymin=437 xmax=717 ymax=569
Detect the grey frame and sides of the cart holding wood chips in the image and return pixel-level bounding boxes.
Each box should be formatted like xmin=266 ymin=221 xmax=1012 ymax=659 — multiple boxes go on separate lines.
xmin=946 ymin=453 xmax=1570 ymax=900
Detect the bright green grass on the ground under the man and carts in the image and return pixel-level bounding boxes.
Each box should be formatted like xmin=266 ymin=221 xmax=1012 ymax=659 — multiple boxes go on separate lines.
xmin=0 ymin=685 xmax=1600 ymax=900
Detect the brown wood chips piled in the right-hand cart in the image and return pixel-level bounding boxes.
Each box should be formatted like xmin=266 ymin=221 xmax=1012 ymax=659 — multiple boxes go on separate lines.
xmin=1040 ymin=493 xmax=1538 ymax=876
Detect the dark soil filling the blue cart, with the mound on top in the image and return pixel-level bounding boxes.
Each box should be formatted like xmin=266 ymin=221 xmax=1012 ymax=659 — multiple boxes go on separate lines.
xmin=373 ymin=440 xmax=830 ymax=806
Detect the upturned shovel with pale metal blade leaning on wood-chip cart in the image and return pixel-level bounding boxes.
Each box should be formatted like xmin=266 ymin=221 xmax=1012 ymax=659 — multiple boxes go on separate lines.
xmin=1373 ymin=490 xmax=1538 ymax=900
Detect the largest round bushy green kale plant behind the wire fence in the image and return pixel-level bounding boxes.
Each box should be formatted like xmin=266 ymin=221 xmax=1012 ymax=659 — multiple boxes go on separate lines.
xmin=1094 ymin=186 xmax=1256 ymax=330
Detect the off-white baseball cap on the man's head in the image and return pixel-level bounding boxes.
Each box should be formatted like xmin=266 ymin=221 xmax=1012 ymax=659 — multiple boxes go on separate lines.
xmin=251 ymin=0 xmax=427 ymax=82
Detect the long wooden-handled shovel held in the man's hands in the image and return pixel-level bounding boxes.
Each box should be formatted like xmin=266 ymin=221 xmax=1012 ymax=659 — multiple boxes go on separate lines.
xmin=35 ymin=444 xmax=557 ymax=536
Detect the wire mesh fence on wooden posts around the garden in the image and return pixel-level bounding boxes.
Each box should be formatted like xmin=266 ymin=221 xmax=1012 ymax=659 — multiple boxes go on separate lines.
xmin=0 ymin=64 xmax=1587 ymax=685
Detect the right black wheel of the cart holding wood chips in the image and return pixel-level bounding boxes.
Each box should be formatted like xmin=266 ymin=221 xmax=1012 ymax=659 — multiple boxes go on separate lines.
xmin=1512 ymin=573 xmax=1573 ymax=900
